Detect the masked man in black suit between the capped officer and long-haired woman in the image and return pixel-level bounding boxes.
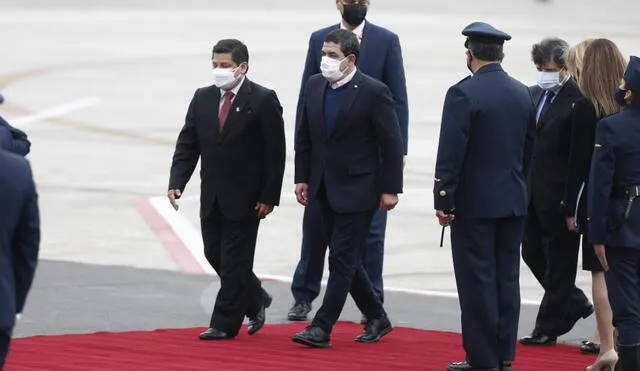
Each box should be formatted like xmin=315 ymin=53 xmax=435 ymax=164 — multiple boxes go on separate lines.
xmin=520 ymin=38 xmax=593 ymax=345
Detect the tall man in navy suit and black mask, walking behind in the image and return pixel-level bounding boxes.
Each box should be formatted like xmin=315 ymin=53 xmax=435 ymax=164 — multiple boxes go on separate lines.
xmin=288 ymin=0 xmax=409 ymax=321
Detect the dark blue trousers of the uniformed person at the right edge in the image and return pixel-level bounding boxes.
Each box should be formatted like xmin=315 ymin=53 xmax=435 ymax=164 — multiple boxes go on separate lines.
xmin=605 ymin=246 xmax=640 ymax=347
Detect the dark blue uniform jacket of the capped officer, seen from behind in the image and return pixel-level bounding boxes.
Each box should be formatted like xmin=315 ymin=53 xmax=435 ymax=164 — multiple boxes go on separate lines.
xmin=433 ymin=63 xmax=536 ymax=218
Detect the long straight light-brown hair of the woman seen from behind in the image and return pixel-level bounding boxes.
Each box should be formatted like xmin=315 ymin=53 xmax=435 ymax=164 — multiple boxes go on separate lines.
xmin=580 ymin=39 xmax=627 ymax=117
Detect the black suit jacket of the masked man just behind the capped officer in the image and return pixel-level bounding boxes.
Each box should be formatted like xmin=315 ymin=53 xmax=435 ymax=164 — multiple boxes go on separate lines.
xmin=529 ymin=78 xmax=582 ymax=217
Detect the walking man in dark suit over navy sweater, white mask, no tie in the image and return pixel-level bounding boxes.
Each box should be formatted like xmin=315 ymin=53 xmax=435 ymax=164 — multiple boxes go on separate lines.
xmin=293 ymin=30 xmax=403 ymax=347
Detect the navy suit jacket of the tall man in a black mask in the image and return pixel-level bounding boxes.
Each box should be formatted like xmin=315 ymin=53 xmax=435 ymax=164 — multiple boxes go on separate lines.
xmin=296 ymin=21 xmax=409 ymax=155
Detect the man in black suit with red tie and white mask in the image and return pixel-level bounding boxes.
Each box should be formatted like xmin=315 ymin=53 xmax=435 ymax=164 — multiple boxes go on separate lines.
xmin=168 ymin=40 xmax=286 ymax=340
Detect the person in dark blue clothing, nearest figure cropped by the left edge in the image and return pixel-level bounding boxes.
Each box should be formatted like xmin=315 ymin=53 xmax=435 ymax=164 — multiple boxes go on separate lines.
xmin=0 ymin=149 xmax=40 ymax=370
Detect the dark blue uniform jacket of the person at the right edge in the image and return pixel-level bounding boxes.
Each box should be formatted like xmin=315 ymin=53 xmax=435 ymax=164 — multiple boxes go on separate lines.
xmin=587 ymin=105 xmax=640 ymax=249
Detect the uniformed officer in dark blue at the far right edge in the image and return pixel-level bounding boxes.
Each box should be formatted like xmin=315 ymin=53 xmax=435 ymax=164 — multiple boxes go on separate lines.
xmin=587 ymin=56 xmax=640 ymax=371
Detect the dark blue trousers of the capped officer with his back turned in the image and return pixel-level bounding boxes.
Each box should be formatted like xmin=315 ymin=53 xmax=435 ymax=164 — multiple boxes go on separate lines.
xmin=451 ymin=217 xmax=524 ymax=369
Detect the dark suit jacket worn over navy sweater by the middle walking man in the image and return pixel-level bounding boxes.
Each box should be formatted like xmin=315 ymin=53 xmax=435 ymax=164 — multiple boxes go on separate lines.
xmin=295 ymin=71 xmax=403 ymax=213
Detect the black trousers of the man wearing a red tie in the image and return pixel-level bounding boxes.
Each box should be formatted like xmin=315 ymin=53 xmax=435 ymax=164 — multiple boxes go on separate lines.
xmin=200 ymin=205 xmax=267 ymax=336
